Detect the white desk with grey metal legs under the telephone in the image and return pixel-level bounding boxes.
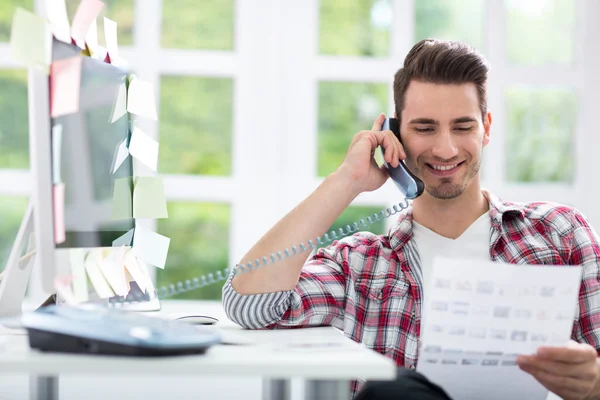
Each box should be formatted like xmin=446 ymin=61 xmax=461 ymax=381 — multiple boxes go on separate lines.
xmin=0 ymin=301 xmax=396 ymax=400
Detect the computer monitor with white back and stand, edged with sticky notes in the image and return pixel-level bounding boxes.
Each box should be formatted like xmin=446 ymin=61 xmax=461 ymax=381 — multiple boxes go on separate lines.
xmin=0 ymin=39 xmax=157 ymax=315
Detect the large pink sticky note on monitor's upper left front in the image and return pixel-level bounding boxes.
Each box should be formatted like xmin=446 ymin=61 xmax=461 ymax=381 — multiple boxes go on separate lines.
xmin=50 ymin=56 xmax=83 ymax=118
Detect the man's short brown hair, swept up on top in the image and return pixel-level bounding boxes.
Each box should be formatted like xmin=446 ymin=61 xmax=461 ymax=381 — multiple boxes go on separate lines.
xmin=394 ymin=39 xmax=489 ymax=124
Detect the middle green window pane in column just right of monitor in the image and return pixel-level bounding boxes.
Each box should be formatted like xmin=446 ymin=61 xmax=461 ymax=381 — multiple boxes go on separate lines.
xmin=159 ymin=76 xmax=233 ymax=176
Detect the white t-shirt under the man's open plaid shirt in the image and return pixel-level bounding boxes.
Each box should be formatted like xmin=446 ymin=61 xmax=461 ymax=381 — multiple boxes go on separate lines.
xmin=413 ymin=212 xmax=492 ymax=302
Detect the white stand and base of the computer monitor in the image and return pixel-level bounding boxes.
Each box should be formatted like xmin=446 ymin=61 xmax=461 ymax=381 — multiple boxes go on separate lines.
xmin=0 ymin=200 xmax=161 ymax=325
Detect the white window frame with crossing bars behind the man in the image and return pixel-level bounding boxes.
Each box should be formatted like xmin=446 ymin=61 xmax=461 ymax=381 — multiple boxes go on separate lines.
xmin=0 ymin=0 xmax=600 ymax=296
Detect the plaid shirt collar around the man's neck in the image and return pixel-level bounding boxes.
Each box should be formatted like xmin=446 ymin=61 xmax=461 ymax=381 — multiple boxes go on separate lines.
xmin=388 ymin=189 xmax=525 ymax=249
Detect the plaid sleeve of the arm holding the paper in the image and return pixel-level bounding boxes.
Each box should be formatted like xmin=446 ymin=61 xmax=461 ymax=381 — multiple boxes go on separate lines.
xmin=569 ymin=211 xmax=600 ymax=354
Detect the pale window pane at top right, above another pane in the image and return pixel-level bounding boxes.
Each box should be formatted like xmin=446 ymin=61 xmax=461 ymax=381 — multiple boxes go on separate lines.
xmin=505 ymin=0 xmax=575 ymax=65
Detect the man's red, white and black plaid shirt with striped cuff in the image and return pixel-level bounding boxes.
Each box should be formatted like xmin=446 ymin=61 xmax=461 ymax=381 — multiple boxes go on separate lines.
xmin=223 ymin=191 xmax=600 ymax=390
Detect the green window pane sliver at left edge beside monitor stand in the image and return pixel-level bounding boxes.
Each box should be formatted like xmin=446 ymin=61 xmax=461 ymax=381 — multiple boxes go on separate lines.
xmin=0 ymin=196 xmax=28 ymax=271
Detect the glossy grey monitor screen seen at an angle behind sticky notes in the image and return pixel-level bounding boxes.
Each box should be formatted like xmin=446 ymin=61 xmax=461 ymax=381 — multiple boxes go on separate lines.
xmin=50 ymin=40 xmax=135 ymax=248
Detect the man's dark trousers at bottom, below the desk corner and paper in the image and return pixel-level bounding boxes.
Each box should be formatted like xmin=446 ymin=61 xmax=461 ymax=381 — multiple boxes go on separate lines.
xmin=354 ymin=368 xmax=452 ymax=400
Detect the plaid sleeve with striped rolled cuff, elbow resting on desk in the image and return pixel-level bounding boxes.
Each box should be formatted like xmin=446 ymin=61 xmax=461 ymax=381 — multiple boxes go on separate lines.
xmin=223 ymin=242 xmax=347 ymax=329
